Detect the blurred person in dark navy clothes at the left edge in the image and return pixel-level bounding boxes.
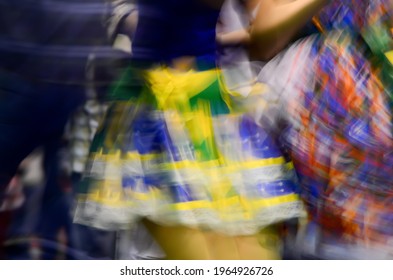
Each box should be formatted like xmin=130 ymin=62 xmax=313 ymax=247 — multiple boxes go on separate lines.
xmin=0 ymin=0 xmax=125 ymax=258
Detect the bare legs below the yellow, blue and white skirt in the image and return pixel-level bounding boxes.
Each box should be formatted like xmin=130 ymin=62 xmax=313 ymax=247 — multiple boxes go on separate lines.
xmin=144 ymin=220 xmax=280 ymax=260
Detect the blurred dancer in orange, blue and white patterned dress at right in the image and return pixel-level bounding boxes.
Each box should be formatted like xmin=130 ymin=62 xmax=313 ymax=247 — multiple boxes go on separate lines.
xmin=252 ymin=0 xmax=393 ymax=259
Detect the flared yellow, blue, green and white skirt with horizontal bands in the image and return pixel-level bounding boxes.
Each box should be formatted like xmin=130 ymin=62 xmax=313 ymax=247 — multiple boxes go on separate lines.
xmin=75 ymin=67 xmax=305 ymax=235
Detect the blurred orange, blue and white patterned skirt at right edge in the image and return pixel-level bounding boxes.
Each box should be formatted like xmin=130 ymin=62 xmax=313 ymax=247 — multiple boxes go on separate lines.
xmin=259 ymin=25 xmax=393 ymax=244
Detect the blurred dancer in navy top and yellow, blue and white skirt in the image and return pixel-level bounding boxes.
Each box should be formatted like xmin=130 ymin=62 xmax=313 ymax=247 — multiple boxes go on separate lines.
xmin=75 ymin=0 xmax=308 ymax=259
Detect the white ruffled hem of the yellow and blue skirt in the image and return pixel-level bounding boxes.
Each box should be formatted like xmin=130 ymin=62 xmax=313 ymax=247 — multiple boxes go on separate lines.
xmin=74 ymin=201 xmax=307 ymax=236
